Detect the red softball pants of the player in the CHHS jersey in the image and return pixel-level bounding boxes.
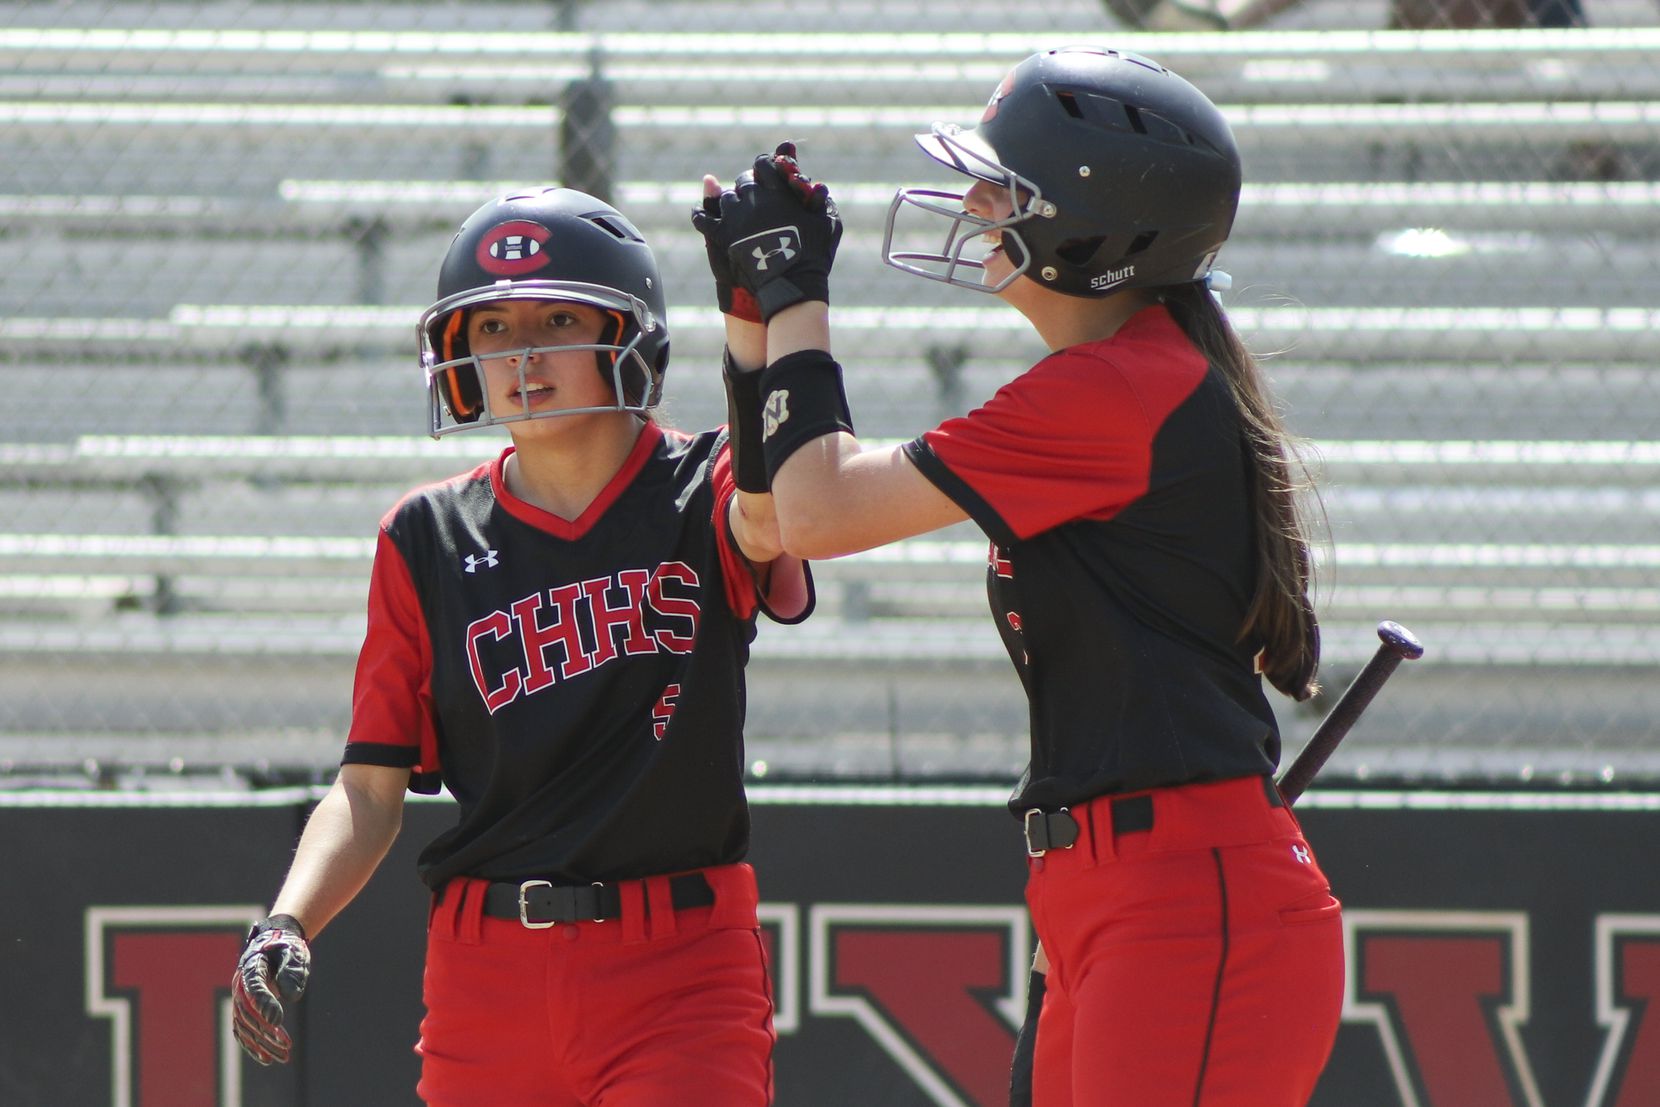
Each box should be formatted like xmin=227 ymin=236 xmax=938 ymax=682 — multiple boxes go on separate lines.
xmin=415 ymin=865 xmax=774 ymax=1107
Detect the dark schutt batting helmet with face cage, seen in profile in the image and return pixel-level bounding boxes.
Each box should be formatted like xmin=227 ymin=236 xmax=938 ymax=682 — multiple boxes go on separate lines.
xmin=883 ymin=46 xmax=1242 ymax=297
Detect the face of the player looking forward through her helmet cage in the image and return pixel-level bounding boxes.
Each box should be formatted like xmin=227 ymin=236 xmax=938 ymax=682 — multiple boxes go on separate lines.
xmin=466 ymin=300 xmax=616 ymax=422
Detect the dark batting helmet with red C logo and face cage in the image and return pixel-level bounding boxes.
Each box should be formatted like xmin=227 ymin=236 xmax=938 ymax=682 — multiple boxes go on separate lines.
xmin=417 ymin=188 xmax=669 ymax=438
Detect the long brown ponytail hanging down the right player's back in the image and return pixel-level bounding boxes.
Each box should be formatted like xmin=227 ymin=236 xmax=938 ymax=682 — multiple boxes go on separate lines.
xmin=1160 ymin=282 xmax=1320 ymax=700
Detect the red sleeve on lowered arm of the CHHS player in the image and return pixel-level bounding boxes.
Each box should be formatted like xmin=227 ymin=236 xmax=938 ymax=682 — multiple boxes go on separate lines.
xmin=342 ymin=528 xmax=438 ymax=792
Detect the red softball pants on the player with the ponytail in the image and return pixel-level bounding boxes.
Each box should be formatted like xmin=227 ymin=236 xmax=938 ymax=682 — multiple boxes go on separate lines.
xmin=1026 ymin=777 xmax=1343 ymax=1107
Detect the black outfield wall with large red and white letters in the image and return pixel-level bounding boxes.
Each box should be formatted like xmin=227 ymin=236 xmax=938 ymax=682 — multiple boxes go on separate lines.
xmin=0 ymin=787 xmax=1660 ymax=1107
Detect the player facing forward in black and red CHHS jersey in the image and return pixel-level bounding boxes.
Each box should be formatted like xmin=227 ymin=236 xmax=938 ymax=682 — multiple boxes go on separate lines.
xmin=232 ymin=188 xmax=812 ymax=1107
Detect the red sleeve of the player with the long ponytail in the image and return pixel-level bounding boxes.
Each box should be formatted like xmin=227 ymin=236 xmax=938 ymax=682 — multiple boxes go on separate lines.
xmin=906 ymin=309 xmax=1207 ymax=544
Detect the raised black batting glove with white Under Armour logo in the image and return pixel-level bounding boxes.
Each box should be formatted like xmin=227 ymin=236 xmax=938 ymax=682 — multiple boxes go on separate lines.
xmin=719 ymin=143 xmax=842 ymax=322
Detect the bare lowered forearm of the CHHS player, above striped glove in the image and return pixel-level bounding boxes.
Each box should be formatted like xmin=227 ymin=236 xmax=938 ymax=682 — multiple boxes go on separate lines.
xmin=271 ymin=780 xmax=403 ymax=938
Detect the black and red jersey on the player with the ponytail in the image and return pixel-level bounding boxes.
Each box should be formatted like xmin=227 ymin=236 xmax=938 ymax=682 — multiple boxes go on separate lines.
xmin=906 ymin=307 xmax=1280 ymax=812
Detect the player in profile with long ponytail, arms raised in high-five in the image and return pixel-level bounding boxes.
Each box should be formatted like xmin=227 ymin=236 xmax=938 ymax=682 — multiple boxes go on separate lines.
xmin=702 ymin=46 xmax=1343 ymax=1107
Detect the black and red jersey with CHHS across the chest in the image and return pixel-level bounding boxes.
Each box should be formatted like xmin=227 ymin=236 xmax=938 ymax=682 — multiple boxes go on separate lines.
xmin=344 ymin=425 xmax=812 ymax=888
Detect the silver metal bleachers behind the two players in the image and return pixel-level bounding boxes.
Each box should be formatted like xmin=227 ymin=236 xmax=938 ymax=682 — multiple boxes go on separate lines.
xmin=0 ymin=0 xmax=1660 ymax=782
